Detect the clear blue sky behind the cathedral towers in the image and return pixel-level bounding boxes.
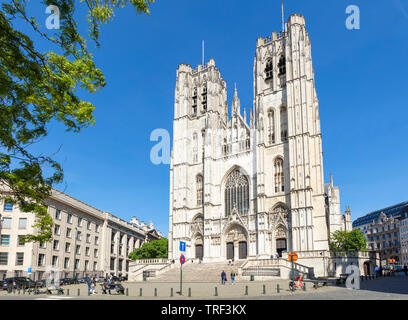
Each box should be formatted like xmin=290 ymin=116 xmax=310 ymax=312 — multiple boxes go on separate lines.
xmin=19 ymin=0 xmax=408 ymax=235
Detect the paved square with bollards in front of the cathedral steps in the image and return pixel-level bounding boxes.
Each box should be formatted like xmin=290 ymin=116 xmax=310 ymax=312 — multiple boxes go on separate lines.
xmin=0 ymin=276 xmax=408 ymax=300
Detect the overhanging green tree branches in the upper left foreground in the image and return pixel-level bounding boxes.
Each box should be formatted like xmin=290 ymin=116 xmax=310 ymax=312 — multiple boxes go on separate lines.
xmin=0 ymin=0 xmax=154 ymax=242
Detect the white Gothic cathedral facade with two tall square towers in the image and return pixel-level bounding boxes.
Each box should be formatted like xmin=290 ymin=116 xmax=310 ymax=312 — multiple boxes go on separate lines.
xmin=169 ymin=14 xmax=351 ymax=262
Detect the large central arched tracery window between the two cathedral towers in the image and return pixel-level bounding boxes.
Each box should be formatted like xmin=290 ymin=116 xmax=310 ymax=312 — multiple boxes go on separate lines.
xmin=225 ymin=170 xmax=249 ymax=216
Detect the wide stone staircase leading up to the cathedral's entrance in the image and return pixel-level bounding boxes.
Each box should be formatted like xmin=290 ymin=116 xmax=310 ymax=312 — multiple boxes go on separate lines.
xmin=148 ymin=261 xmax=245 ymax=283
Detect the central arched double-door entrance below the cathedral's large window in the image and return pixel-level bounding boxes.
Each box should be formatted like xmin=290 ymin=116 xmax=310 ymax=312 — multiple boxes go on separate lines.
xmin=225 ymin=224 xmax=248 ymax=260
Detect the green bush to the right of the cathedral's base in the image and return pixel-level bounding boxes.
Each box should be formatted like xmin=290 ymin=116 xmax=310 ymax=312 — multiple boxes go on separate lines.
xmin=330 ymin=229 xmax=367 ymax=251
